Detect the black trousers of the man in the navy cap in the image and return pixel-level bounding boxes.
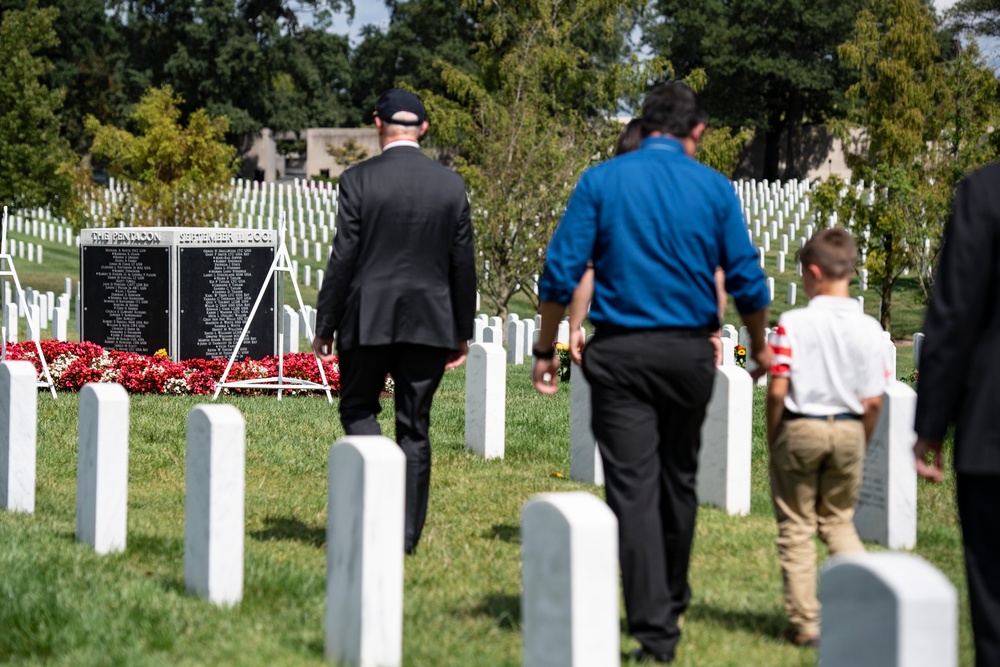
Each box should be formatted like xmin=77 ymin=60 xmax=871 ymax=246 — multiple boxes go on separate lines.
xmin=339 ymin=343 xmax=449 ymax=553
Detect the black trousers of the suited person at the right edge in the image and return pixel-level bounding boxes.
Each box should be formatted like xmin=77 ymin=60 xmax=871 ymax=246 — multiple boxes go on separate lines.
xmin=957 ymin=473 xmax=1000 ymax=667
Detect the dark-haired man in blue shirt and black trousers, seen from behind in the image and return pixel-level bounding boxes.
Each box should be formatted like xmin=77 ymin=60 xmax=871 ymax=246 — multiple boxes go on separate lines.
xmin=533 ymin=82 xmax=771 ymax=662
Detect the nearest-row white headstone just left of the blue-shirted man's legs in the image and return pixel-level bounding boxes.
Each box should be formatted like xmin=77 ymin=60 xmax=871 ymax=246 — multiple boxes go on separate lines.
xmin=521 ymin=491 xmax=621 ymax=667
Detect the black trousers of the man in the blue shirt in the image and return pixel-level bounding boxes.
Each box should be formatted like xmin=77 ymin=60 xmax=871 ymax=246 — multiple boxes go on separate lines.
xmin=583 ymin=329 xmax=715 ymax=655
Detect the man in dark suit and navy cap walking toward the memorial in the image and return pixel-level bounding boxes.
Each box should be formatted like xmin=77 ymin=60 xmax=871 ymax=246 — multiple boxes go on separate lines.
xmin=313 ymin=89 xmax=476 ymax=553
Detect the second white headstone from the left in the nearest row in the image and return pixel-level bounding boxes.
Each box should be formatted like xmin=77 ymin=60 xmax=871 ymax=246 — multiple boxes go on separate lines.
xmin=76 ymin=382 xmax=129 ymax=554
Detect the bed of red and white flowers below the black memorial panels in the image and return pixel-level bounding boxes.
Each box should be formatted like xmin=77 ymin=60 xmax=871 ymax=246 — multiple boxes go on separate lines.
xmin=1 ymin=340 xmax=340 ymax=395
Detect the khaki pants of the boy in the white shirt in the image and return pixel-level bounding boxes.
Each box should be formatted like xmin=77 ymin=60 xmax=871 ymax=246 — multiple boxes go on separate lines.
xmin=770 ymin=418 xmax=865 ymax=636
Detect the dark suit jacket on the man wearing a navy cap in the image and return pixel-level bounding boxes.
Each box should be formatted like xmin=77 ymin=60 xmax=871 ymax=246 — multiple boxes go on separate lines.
xmin=316 ymin=146 xmax=476 ymax=350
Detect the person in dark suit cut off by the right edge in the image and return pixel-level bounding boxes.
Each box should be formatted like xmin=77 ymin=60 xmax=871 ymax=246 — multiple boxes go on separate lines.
xmin=914 ymin=163 xmax=1000 ymax=667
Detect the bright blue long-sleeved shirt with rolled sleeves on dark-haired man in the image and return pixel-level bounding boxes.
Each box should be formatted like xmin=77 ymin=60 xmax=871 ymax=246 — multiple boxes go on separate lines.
xmin=539 ymin=137 xmax=770 ymax=329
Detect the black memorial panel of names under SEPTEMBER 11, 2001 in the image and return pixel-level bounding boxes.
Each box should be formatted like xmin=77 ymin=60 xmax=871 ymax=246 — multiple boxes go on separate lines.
xmin=179 ymin=246 xmax=275 ymax=359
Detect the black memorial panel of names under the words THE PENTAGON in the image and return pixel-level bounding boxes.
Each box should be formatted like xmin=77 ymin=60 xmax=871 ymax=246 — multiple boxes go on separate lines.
xmin=80 ymin=246 xmax=170 ymax=355
